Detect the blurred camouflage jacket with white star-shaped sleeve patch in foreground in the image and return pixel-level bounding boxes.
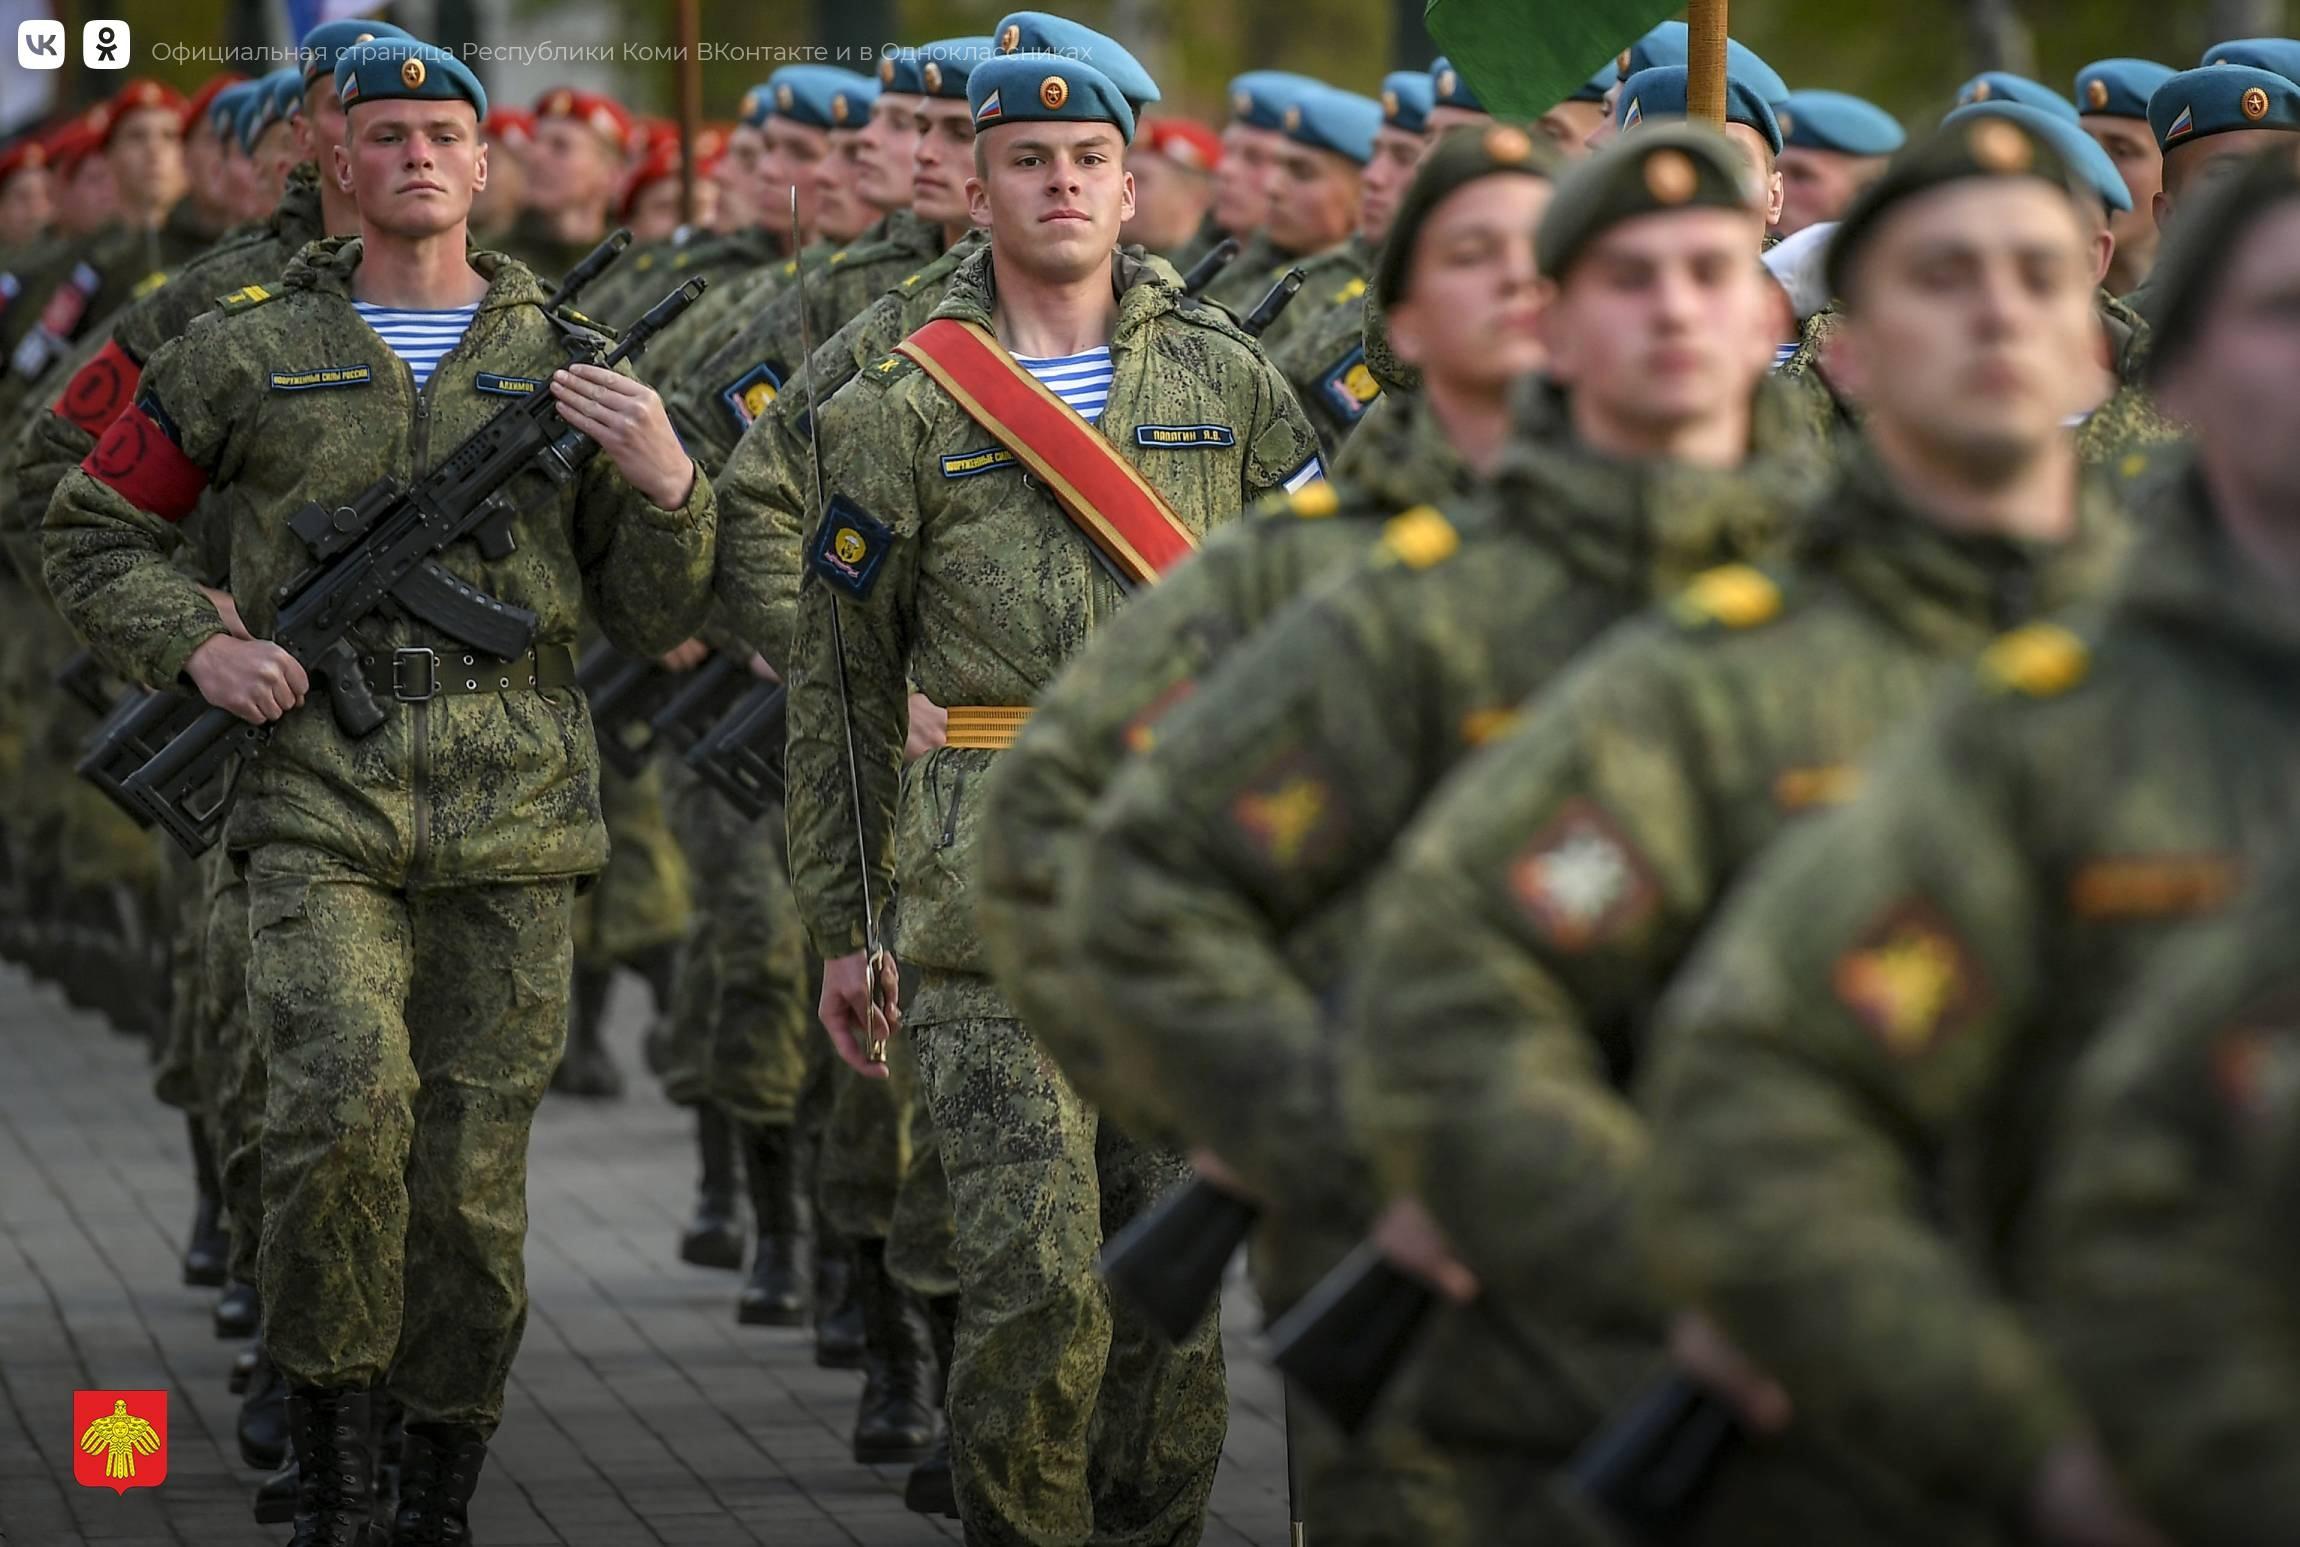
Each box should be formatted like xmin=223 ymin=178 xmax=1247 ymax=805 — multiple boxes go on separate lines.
xmin=1341 ymin=452 xmax=2125 ymax=1542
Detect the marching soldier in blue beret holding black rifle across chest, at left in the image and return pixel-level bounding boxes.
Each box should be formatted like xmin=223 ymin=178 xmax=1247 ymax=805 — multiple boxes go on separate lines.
xmin=46 ymin=39 xmax=715 ymax=1547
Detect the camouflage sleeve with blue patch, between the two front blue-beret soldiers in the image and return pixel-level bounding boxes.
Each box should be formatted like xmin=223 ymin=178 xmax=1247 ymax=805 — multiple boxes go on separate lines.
xmin=665 ymin=209 xmax=943 ymax=469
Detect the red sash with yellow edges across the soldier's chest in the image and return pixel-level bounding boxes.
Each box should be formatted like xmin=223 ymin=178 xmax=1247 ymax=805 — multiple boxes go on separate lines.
xmin=895 ymin=317 xmax=1198 ymax=584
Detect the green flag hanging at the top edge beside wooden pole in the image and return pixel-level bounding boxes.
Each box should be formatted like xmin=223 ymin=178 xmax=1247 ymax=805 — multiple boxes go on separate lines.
xmin=1424 ymin=0 xmax=1684 ymax=117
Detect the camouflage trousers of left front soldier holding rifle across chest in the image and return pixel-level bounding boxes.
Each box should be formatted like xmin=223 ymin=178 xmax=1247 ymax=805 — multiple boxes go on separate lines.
xmin=246 ymin=844 xmax=573 ymax=1432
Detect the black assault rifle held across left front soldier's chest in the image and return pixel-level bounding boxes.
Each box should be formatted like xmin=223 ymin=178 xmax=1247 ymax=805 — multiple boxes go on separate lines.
xmin=122 ymin=278 xmax=706 ymax=855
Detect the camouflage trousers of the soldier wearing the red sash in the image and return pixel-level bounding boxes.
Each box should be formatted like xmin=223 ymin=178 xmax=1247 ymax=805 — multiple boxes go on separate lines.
xmin=906 ymin=972 xmax=1228 ymax=1547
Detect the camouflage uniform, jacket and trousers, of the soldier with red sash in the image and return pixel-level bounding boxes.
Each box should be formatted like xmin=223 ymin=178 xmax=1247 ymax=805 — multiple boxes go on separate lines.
xmin=789 ymin=253 xmax=1316 ymax=1542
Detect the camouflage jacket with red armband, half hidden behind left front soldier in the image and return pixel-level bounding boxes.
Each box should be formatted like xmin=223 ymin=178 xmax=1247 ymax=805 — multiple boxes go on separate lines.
xmin=0 ymin=161 xmax=327 ymax=586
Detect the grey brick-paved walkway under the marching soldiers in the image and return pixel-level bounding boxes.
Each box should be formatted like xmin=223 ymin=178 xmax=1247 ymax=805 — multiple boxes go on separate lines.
xmin=0 ymin=968 xmax=1286 ymax=1547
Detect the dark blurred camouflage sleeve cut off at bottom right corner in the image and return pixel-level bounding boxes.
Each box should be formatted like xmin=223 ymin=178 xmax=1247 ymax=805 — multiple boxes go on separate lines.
xmin=2033 ymin=853 xmax=2300 ymax=1547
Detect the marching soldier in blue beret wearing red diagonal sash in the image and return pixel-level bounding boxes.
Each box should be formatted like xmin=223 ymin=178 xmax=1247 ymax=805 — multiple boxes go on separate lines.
xmin=789 ymin=53 xmax=1320 ymax=1542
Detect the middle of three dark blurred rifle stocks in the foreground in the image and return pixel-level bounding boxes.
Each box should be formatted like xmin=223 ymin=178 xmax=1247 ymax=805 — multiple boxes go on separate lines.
xmin=1270 ymin=1241 xmax=1438 ymax=1434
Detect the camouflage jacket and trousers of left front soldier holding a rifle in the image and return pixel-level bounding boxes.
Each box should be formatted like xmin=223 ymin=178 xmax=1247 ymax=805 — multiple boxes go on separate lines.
xmin=46 ymin=239 xmax=715 ymax=1427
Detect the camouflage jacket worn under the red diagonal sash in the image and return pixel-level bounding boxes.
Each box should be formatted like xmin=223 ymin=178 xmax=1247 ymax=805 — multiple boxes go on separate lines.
xmin=789 ymin=248 xmax=1318 ymax=972
